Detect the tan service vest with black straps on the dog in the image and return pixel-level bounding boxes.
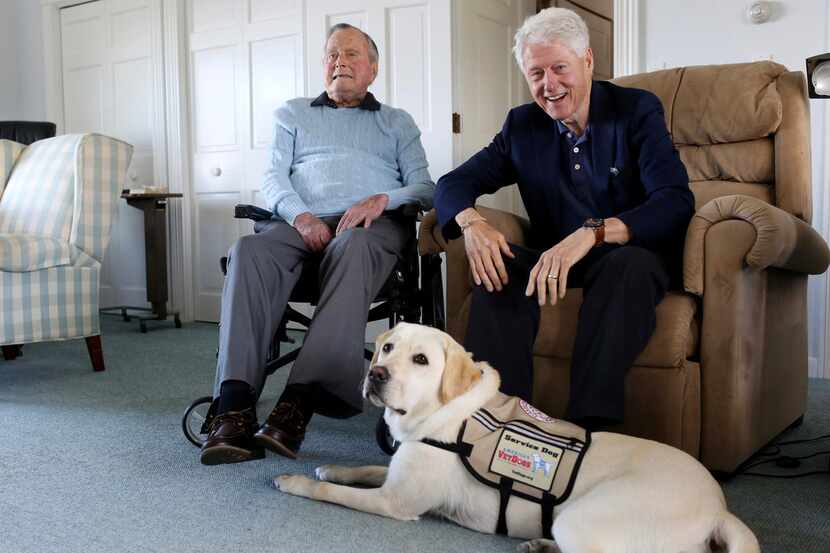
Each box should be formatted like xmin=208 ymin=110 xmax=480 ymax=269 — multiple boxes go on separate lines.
xmin=421 ymin=393 xmax=591 ymax=538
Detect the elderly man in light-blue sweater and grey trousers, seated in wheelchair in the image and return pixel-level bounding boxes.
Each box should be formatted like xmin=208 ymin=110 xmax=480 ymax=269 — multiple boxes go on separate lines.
xmin=201 ymin=24 xmax=435 ymax=465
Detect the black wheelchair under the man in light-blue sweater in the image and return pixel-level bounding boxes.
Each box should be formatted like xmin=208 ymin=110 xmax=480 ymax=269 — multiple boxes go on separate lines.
xmin=182 ymin=204 xmax=446 ymax=455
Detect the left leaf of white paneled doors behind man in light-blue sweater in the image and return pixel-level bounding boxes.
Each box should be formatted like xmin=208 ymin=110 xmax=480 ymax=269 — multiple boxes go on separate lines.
xmin=187 ymin=0 xmax=305 ymax=321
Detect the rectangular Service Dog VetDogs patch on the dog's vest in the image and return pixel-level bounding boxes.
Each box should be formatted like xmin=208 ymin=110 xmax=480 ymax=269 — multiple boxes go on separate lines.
xmin=490 ymin=429 xmax=564 ymax=491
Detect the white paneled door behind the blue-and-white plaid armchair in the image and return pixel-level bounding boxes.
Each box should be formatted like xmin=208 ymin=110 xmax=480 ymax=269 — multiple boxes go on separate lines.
xmin=60 ymin=0 xmax=166 ymax=306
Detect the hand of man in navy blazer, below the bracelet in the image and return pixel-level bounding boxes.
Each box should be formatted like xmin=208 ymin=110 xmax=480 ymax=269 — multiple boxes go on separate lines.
xmin=464 ymin=218 xmax=515 ymax=292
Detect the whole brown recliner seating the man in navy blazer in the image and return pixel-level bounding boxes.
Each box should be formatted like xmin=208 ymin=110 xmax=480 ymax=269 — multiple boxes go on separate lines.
xmin=420 ymin=62 xmax=830 ymax=472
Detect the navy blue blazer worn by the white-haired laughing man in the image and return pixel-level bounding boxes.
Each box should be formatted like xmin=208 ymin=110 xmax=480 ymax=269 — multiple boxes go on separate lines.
xmin=435 ymin=81 xmax=694 ymax=265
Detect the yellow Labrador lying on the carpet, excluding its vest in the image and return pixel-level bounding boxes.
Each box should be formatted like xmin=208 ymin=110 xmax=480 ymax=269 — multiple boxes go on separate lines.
xmin=274 ymin=323 xmax=760 ymax=553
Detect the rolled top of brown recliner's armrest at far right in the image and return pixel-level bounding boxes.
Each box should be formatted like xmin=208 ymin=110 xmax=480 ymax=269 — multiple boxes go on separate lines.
xmin=683 ymin=195 xmax=830 ymax=296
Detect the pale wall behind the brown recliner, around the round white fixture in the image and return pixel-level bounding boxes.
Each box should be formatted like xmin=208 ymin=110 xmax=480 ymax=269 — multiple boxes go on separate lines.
xmin=640 ymin=0 xmax=830 ymax=378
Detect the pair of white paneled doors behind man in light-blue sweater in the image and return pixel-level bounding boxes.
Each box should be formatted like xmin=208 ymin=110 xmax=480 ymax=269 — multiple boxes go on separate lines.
xmin=187 ymin=0 xmax=452 ymax=321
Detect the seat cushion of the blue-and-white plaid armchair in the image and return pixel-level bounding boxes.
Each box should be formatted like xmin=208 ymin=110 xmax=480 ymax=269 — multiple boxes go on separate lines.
xmin=0 ymin=234 xmax=72 ymax=272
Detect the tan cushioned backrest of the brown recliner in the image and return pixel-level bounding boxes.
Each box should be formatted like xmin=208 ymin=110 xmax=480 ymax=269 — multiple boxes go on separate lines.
xmin=614 ymin=61 xmax=812 ymax=222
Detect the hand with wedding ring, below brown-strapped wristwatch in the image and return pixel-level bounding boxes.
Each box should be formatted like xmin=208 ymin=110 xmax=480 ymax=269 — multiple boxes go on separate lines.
xmin=525 ymin=227 xmax=596 ymax=305
